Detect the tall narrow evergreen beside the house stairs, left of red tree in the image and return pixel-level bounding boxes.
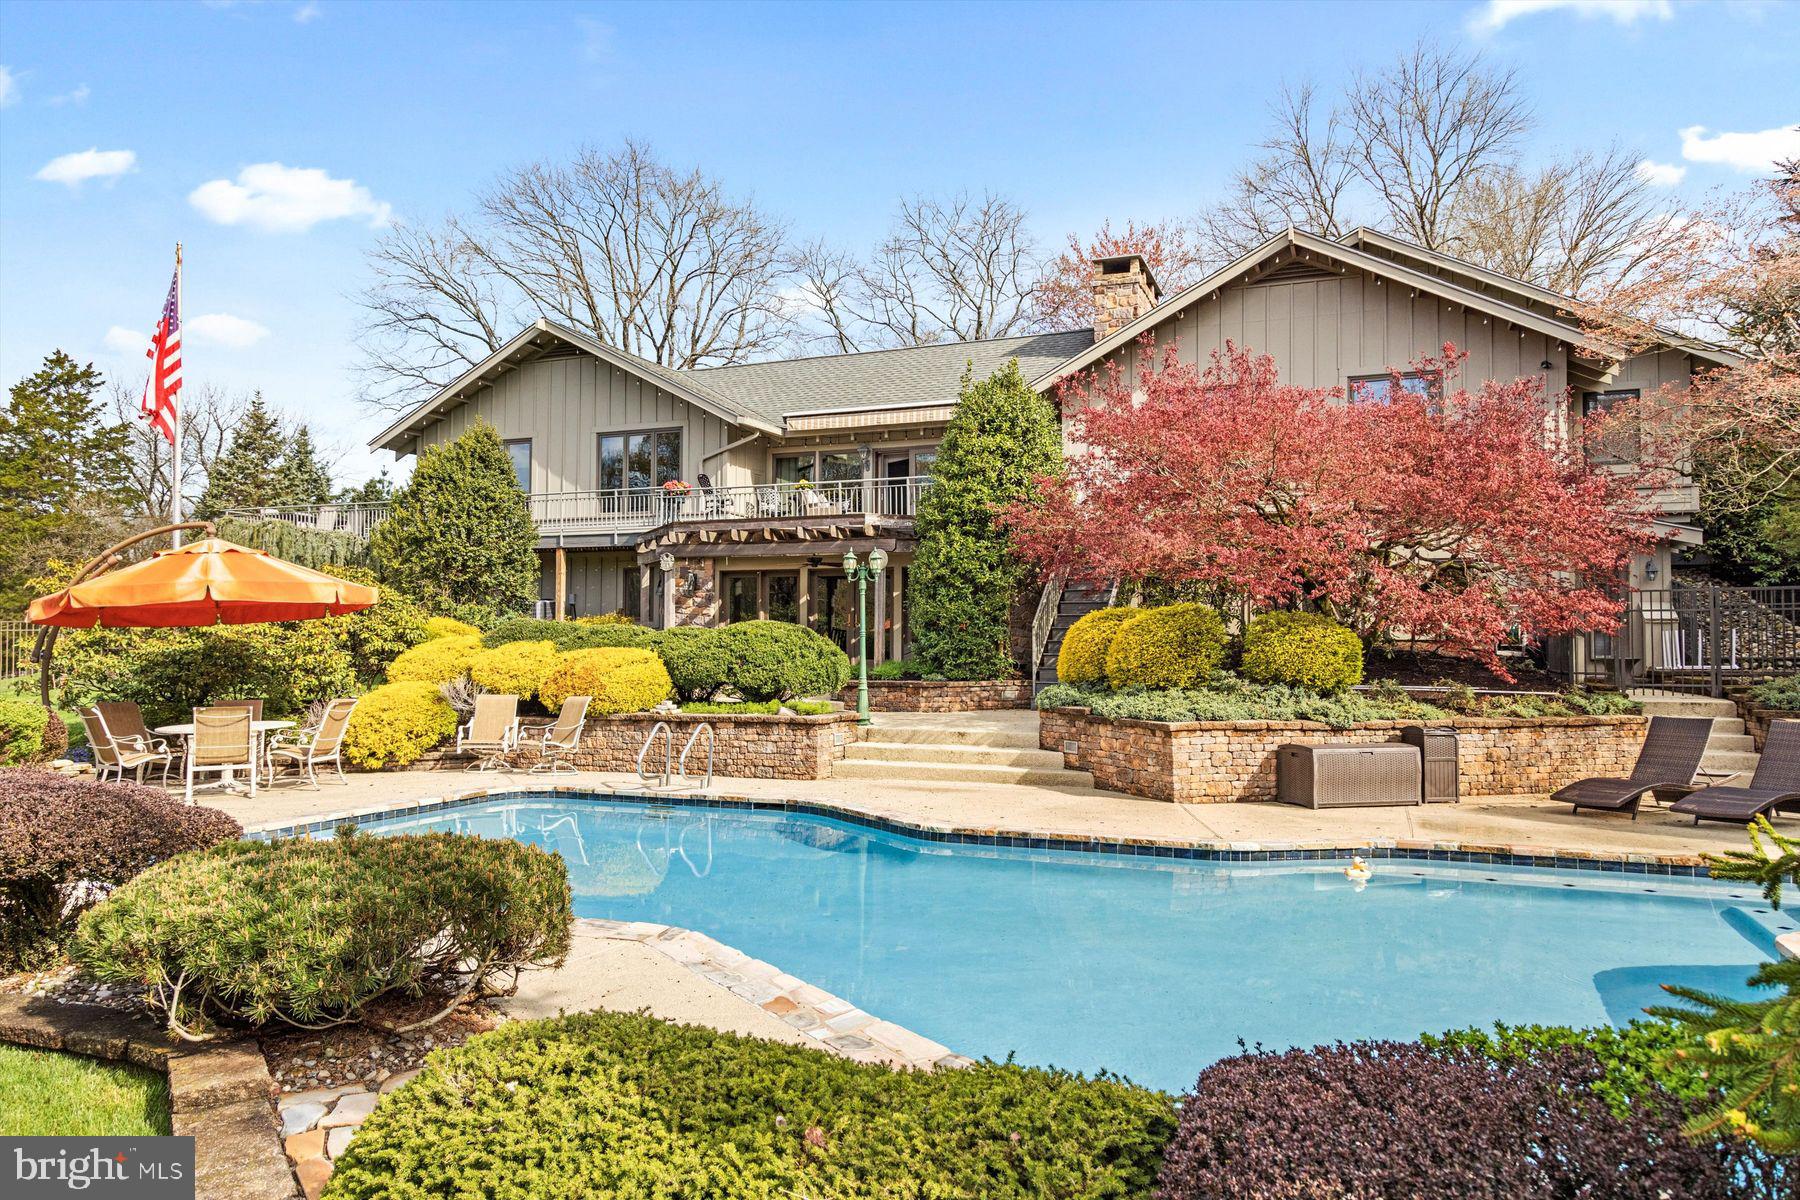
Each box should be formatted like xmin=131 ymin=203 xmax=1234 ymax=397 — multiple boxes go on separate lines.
xmin=907 ymin=360 xmax=1062 ymax=678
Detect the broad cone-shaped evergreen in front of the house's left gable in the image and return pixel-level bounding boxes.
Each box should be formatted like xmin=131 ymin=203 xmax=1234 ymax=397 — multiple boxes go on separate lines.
xmin=369 ymin=421 xmax=538 ymax=613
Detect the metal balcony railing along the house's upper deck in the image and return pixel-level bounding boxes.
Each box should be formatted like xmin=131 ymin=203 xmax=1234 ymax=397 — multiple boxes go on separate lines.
xmin=229 ymin=475 xmax=931 ymax=540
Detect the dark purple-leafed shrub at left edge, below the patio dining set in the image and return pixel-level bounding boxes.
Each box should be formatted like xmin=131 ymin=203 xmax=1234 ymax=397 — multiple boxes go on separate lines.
xmin=0 ymin=770 xmax=243 ymax=972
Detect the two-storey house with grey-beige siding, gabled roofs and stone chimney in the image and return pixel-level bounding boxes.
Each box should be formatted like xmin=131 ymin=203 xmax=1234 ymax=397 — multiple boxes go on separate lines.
xmin=343 ymin=228 xmax=1730 ymax=676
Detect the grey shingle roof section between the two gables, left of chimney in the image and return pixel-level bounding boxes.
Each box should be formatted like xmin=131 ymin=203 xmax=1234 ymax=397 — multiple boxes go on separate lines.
xmin=680 ymin=329 xmax=1094 ymax=421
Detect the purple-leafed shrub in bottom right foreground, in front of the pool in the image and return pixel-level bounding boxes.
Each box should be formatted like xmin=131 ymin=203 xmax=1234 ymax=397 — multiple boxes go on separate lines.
xmin=1157 ymin=1042 xmax=1769 ymax=1200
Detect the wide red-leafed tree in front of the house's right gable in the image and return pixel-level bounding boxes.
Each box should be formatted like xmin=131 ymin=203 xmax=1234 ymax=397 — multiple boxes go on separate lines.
xmin=1006 ymin=344 xmax=1652 ymax=669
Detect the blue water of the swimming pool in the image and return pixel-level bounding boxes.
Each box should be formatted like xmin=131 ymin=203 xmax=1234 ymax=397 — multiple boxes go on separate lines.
xmin=351 ymin=799 xmax=1771 ymax=1088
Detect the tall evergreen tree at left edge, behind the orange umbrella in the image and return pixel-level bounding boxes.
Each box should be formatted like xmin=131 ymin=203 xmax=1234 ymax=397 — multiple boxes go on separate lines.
xmin=0 ymin=351 xmax=130 ymax=610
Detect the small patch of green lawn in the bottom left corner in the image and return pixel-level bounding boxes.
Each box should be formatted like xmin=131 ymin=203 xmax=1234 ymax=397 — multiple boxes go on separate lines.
xmin=0 ymin=1043 xmax=169 ymax=1137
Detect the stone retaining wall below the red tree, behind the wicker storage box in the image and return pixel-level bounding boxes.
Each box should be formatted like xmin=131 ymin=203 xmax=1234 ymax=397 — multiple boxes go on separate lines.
xmin=1039 ymin=709 xmax=1645 ymax=804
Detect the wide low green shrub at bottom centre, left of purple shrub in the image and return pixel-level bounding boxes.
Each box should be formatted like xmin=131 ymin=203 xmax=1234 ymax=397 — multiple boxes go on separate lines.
xmin=326 ymin=1013 xmax=1174 ymax=1200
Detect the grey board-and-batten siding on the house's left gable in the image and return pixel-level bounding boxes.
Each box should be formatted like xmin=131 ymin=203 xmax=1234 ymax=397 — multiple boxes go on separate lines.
xmin=419 ymin=354 xmax=749 ymax=493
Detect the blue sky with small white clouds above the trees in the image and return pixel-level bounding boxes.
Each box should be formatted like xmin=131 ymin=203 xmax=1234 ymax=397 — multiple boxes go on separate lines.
xmin=0 ymin=0 xmax=1800 ymax=479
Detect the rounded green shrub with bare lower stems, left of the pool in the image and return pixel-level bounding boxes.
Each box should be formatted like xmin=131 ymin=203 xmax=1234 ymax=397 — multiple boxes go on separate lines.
xmin=70 ymin=833 xmax=572 ymax=1036
